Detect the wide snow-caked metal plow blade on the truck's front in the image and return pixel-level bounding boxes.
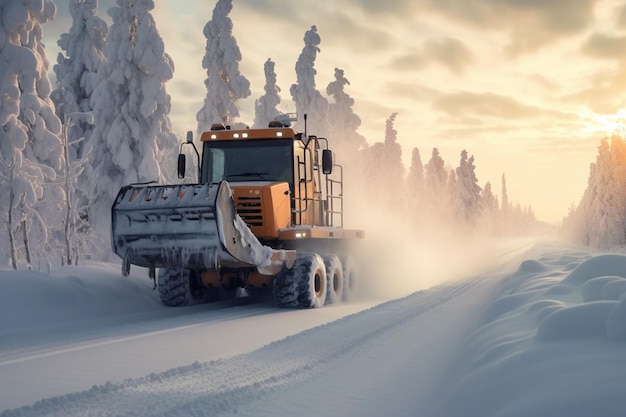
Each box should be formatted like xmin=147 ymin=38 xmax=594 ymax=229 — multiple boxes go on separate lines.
xmin=111 ymin=182 xmax=296 ymax=275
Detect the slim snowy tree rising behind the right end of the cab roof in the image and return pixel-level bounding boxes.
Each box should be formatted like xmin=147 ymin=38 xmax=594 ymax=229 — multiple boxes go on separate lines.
xmin=289 ymin=26 xmax=330 ymax=137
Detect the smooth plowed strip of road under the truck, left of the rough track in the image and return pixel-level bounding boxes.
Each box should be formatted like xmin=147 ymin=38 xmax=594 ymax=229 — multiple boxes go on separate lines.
xmin=0 ymin=296 xmax=380 ymax=408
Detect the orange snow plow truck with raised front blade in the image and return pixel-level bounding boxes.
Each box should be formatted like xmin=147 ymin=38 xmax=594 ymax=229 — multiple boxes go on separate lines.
xmin=111 ymin=115 xmax=364 ymax=308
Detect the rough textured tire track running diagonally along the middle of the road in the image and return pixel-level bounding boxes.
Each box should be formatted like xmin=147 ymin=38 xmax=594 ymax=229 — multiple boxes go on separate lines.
xmin=0 ymin=277 xmax=494 ymax=417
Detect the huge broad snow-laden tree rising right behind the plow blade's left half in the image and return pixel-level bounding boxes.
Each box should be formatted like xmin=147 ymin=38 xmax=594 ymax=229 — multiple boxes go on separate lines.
xmin=89 ymin=0 xmax=176 ymax=249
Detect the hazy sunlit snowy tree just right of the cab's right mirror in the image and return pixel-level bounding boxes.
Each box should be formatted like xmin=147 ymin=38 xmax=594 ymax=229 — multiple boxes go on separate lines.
xmin=326 ymin=68 xmax=366 ymax=156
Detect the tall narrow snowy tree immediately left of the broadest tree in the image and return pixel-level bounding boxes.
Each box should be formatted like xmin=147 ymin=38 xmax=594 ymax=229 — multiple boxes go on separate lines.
xmin=51 ymin=0 xmax=108 ymax=264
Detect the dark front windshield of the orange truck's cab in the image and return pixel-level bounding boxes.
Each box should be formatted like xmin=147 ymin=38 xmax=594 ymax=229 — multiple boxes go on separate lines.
xmin=201 ymin=139 xmax=293 ymax=184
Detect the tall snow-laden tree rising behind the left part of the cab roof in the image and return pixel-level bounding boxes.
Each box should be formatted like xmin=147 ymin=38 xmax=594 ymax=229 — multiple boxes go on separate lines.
xmin=196 ymin=0 xmax=251 ymax=133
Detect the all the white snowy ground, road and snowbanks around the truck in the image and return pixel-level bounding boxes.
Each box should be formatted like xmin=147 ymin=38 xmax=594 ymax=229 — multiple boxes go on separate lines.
xmin=0 ymin=239 xmax=626 ymax=417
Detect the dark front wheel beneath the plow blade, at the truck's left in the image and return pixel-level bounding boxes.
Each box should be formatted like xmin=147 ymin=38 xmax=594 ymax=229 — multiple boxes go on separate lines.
xmin=158 ymin=268 xmax=214 ymax=307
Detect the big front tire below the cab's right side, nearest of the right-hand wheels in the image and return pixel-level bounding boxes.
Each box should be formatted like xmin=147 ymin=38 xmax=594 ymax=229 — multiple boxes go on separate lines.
xmin=274 ymin=253 xmax=327 ymax=308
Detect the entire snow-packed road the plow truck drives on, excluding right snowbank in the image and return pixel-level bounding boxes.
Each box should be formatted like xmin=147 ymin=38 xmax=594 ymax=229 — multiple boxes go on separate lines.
xmin=0 ymin=236 xmax=527 ymax=417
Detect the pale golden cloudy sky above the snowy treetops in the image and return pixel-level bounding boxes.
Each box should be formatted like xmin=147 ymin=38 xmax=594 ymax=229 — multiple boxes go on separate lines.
xmin=44 ymin=0 xmax=626 ymax=222
